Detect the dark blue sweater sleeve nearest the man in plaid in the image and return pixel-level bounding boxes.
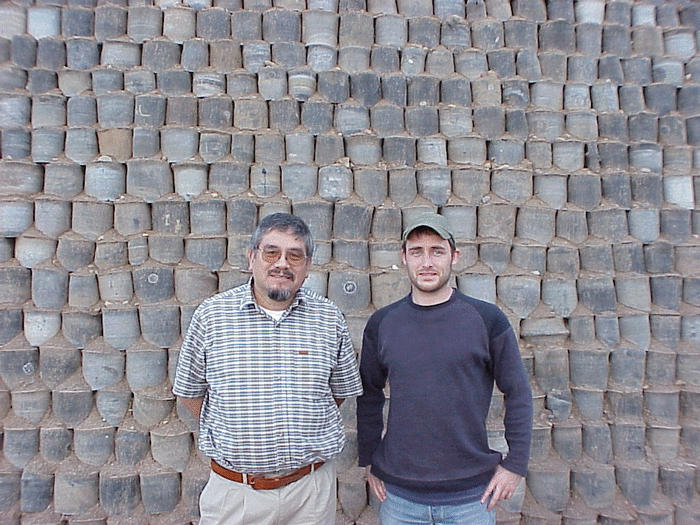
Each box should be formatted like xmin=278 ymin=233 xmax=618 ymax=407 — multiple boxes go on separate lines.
xmin=357 ymin=316 xmax=386 ymax=467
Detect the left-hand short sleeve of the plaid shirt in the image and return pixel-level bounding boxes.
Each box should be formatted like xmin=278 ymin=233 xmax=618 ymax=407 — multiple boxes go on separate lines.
xmin=173 ymin=306 xmax=207 ymax=398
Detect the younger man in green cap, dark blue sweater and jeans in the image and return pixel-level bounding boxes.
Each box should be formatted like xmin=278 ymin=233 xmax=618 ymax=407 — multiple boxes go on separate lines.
xmin=357 ymin=213 xmax=532 ymax=525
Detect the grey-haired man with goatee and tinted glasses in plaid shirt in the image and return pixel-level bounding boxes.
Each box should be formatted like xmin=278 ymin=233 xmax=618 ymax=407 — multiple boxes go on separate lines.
xmin=173 ymin=213 xmax=362 ymax=525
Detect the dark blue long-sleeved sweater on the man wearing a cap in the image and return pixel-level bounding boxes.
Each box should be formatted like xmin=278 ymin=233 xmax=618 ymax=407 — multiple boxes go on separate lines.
xmin=357 ymin=290 xmax=532 ymax=491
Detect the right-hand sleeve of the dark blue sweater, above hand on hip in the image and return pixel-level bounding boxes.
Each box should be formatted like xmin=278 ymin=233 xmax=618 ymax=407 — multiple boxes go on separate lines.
xmin=491 ymin=316 xmax=532 ymax=476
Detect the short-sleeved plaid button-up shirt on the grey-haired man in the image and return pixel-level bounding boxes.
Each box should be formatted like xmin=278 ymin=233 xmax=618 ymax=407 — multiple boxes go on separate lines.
xmin=173 ymin=282 xmax=362 ymax=474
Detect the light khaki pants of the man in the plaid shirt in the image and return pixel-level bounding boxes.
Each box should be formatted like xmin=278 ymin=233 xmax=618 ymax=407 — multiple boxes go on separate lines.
xmin=199 ymin=461 xmax=336 ymax=525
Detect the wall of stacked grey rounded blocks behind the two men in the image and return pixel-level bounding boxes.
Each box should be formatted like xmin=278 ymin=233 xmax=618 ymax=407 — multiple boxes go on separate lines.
xmin=0 ymin=0 xmax=700 ymax=525
